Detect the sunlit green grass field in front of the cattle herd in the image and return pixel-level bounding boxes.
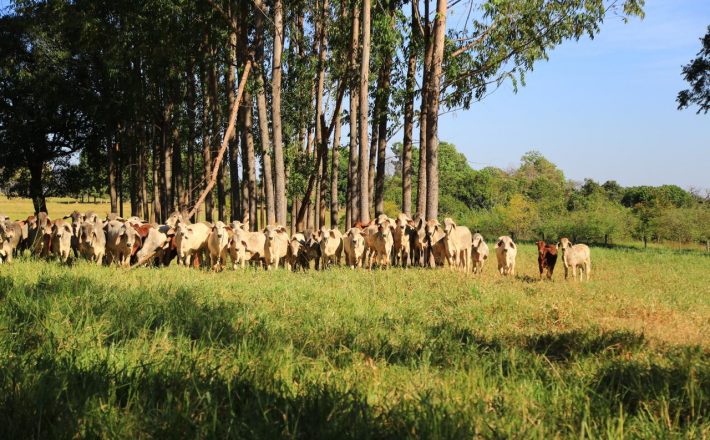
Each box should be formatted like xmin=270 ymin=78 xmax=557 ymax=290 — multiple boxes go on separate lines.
xmin=0 ymin=245 xmax=710 ymax=438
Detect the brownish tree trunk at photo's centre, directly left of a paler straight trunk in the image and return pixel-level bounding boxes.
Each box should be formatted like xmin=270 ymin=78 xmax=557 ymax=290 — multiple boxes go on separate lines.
xmin=346 ymin=2 xmax=360 ymax=230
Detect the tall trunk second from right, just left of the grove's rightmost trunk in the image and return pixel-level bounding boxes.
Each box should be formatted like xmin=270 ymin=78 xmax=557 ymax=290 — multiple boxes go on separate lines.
xmin=417 ymin=0 xmax=433 ymax=218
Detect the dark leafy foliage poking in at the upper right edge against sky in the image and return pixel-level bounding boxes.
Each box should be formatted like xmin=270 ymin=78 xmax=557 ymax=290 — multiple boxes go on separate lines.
xmin=676 ymin=26 xmax=710 ymax=114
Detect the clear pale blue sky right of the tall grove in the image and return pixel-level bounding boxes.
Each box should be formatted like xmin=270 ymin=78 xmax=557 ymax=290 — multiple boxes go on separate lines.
xmin=428 ymin=0 xmax=710 ymax=190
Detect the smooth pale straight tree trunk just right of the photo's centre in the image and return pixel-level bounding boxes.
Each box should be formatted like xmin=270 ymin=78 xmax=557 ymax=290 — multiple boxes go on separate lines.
xmin=359 ymin=0 xmax=370 ymax=223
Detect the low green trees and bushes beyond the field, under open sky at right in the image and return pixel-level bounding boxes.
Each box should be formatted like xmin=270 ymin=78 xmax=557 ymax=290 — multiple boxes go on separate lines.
xmin=386 ymin=147 xmax=710 ymax=250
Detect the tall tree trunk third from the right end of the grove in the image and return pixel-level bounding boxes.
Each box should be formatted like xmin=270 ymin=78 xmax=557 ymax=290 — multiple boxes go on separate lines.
xmin=402 ymin=1 xmax=419 ymax=216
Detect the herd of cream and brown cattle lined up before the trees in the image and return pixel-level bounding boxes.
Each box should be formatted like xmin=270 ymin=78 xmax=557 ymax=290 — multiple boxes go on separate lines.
xmin=0 ymin=211 xmax=591 ymax=280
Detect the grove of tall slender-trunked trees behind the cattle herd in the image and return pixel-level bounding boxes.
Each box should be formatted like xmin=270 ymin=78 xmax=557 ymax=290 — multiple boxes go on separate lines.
xmin=0 ymin=0 xmax=643 ymax=230
